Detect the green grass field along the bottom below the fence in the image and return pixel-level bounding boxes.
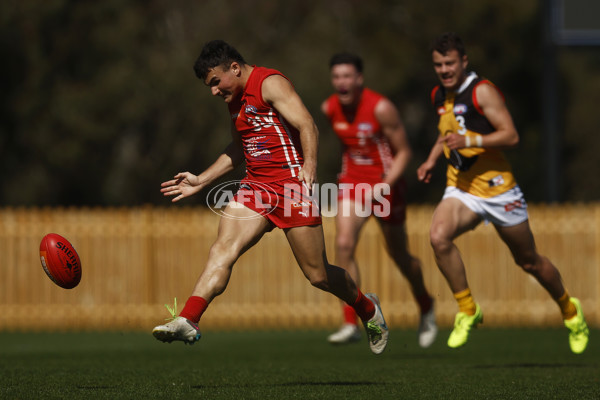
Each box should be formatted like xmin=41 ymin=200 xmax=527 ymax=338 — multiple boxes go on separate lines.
xmin=0 ymin=328 xmax=600 ymax=400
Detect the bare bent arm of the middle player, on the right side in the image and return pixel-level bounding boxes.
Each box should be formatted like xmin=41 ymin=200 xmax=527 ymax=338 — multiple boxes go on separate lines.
xmin=374 ymin=98 xmax=412 ymax=185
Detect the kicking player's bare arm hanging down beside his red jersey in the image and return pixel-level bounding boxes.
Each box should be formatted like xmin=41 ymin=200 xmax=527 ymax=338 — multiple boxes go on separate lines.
xmin=262 ymin=75 xmax=319 ymax=188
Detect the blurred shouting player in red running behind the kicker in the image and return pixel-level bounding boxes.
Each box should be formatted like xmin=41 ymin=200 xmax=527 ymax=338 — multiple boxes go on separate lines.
xmin=321 ymin=53 xmax=437 ymax=347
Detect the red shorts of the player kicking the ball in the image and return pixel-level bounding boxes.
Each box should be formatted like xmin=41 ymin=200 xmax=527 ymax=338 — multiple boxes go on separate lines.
xmin=233 ymin=178 xmax=322 ymax=229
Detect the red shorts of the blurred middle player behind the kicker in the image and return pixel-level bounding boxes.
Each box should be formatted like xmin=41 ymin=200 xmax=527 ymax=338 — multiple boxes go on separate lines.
xmin=338 ymin=176 xmax=406 ymax=225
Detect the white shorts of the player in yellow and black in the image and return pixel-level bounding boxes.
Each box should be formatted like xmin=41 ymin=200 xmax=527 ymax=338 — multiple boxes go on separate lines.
xmin=442 ymin=185 xmax=529 ymax=226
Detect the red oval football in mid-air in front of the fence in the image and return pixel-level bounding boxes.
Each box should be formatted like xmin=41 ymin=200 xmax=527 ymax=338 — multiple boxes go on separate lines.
xmin=40 ymin=233 xmax=81 ymax=289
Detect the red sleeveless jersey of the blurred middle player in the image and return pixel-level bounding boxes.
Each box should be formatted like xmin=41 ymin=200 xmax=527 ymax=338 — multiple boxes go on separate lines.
xmin=326 ymin=88 xmax=393 ymax=184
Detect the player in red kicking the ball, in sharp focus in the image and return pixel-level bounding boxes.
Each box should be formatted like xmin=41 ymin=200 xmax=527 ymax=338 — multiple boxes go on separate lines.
xmin=153 ymin=40 xmax=388 ymax=354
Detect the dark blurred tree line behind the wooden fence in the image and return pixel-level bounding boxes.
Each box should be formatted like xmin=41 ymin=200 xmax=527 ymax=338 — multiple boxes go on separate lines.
xmin=0 ymin=0 xmax=600 ymax=206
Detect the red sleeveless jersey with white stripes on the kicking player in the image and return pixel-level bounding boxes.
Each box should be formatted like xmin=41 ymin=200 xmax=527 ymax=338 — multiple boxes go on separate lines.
xmin=229 ymin=66 xmax=304 ymax=182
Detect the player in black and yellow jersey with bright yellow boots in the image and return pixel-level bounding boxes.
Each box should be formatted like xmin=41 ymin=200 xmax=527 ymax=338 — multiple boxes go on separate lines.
xmin=417 ymin=33 xmax=589 ymax=353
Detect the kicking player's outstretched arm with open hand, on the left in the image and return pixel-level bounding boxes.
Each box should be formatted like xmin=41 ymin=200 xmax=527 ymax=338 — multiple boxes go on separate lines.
xmin=160 ymin=128 xmax=243 ymax=202
